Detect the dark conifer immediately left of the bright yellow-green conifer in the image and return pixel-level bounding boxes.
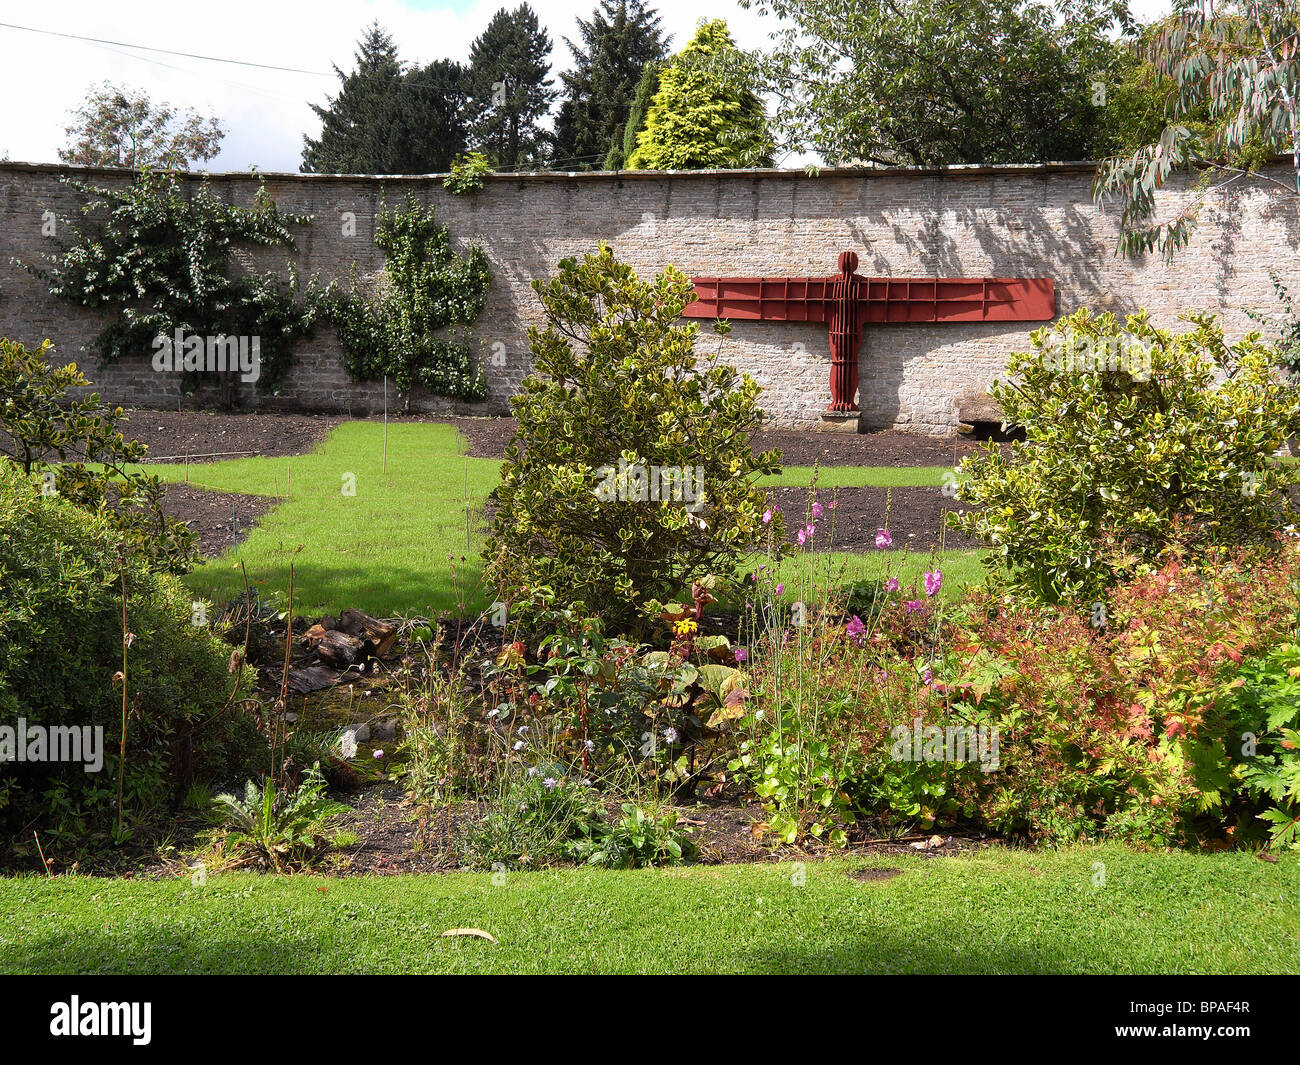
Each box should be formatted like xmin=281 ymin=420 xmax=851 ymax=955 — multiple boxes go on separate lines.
xmin=554 ymin=0 xmax=668 ymax=170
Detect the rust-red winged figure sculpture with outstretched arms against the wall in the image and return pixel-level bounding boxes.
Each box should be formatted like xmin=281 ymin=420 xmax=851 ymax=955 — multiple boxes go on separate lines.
xmin=683 ymin=251 xmax=1056 ymax=411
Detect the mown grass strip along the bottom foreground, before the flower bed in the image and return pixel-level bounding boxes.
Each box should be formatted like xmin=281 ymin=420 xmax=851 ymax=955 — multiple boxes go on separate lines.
xmin=0 ymin=847 xmax=1300 ymax=974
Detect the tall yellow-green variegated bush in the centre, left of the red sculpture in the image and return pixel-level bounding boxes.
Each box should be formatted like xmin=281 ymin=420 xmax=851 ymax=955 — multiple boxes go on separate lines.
xmin=485 ymin=244 xmax=784 ymax=632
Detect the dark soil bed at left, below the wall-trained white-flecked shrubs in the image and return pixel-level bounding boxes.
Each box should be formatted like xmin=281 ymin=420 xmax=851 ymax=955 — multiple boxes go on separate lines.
xmin=121 ymin=410 xmax=347 ymax=462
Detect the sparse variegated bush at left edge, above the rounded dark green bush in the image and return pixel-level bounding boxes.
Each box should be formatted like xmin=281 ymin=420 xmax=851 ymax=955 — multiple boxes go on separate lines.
xmin=0 ymin=338 xmax=198 ymax=573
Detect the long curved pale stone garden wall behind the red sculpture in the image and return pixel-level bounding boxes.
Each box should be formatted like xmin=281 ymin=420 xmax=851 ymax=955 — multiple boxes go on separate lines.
xmin=0 ymin=163 xmax=1300 ymax=434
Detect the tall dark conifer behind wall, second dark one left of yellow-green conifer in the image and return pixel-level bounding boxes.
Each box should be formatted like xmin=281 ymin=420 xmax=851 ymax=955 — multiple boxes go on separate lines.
xmin=469 ymin=4 xmax=556 ymax=170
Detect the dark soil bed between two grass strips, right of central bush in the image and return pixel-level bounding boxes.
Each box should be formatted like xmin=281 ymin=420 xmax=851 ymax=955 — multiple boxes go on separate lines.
xmin=772 ymin=488 xmax=978 ymax=551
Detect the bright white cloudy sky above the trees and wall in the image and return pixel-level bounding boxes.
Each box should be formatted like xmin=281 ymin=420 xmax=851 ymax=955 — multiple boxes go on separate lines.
xmin=0 ymin=0 xmax=1169 ymax=172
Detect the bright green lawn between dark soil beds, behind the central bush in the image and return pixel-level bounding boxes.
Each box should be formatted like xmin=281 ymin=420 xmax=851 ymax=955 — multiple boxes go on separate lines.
xmin=134 ymin=421 xmax=980 ymax=616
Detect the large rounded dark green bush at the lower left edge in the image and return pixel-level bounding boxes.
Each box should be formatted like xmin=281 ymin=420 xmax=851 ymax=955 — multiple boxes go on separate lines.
xmin=0 ymin=462 xmax=265 ymax=845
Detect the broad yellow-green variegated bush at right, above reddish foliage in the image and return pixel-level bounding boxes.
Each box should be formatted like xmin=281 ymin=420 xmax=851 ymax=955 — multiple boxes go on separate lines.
xmin=948 ymin=309 xmax=1300 ymax=601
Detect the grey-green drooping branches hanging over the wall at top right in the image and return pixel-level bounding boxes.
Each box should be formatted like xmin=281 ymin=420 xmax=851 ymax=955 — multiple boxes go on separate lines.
xmin=1093 ymin=0 xmax=1300 ymax=261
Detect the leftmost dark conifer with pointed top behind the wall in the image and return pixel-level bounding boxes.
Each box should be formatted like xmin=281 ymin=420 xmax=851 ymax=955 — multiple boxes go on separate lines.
xmin=299 ymin=22 xmax=402 ymax=174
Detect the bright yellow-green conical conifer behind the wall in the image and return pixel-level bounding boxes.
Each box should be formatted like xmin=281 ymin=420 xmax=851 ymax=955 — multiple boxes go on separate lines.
xmin=628 ymin=18 xmax=772 ymax=170
